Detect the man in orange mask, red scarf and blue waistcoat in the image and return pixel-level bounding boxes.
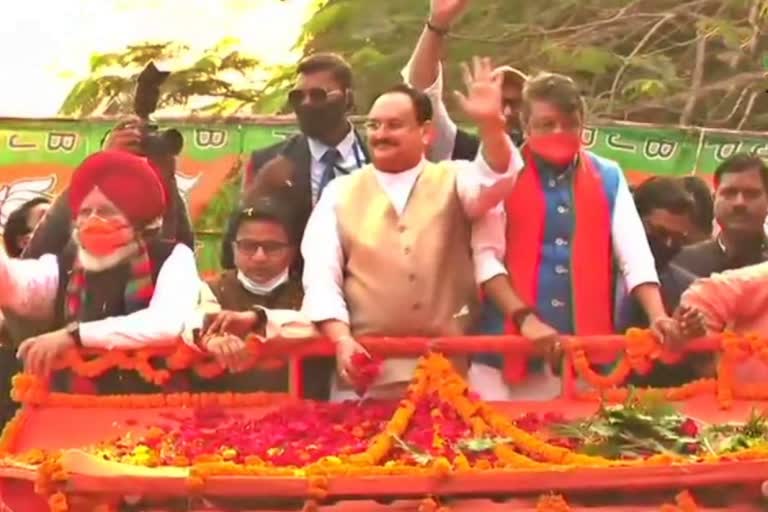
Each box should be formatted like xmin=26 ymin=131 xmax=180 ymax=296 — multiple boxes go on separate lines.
xmin=469 ymin=73 xmax=677 ymax=400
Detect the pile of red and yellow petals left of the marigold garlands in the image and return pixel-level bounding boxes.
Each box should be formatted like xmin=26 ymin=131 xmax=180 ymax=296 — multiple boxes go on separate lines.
xmin=97 ymin=401 xmax=397 ymax=466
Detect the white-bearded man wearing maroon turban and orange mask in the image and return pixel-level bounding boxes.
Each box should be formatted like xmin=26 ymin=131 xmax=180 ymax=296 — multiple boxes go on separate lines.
xmin=0 ymin=151 xmax=200 ymax=393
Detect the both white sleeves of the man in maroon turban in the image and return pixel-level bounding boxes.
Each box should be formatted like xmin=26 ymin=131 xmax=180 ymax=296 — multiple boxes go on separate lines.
xmin=0 ymin=244 xmax=200 ymax=350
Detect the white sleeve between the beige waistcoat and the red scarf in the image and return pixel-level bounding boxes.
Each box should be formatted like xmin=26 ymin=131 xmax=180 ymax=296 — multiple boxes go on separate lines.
xmin=472 ymin=204 xmax=507 ymax=285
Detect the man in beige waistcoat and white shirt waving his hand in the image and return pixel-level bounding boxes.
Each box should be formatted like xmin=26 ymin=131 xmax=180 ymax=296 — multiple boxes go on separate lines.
xmin=301 ymin=59 xmax=522 ymax=399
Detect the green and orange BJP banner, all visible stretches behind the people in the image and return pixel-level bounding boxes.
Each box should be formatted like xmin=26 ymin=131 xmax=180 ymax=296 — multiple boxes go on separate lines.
xmin=0 ymin=118 xmax=768 ymax=272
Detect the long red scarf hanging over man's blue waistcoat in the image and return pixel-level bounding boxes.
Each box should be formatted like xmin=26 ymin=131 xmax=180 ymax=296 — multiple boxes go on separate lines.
xmin=504 ymin=150 xmax=613 ymax=382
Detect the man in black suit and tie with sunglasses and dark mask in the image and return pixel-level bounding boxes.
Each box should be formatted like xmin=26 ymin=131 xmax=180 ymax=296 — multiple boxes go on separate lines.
xmin=221 ymin=53 xmax=369 ymax=269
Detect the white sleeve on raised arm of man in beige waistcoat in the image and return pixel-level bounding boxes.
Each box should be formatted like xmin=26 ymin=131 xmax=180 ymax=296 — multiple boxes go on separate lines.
xmin=451 ymin=140 xmax=523 ymax=219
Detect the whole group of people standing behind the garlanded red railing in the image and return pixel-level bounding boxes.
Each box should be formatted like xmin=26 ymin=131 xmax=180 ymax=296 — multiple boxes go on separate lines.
xmin=0 ymin=0 xmax=768 ymax=424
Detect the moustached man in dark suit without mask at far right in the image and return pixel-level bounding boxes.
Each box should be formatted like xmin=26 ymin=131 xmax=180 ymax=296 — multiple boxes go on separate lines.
xmin=675 ymin=153 xmax=768 ymax=277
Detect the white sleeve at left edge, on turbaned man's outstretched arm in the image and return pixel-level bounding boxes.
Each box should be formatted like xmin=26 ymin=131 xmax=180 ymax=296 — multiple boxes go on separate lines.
xmin=0 ymin=249 xmax=59 ymax=318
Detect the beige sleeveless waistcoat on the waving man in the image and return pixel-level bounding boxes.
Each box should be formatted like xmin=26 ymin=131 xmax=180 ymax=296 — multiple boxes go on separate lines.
xmin=336 ymin=163 xmax=478 ymax=384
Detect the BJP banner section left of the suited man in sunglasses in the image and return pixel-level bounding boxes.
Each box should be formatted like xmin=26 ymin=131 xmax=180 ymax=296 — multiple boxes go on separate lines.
xmin=0 ymin=120 xmax=294 ymax=272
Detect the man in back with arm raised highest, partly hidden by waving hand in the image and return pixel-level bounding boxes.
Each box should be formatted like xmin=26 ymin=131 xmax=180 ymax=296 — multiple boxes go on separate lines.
xmin=403 ymin=0 xmax=528 ymax=162
